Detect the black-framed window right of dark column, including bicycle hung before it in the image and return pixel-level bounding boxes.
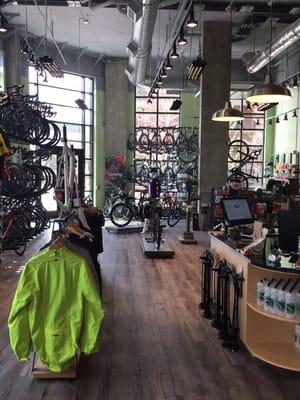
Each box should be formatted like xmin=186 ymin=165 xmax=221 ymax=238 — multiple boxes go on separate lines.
xmin=228 ymin=91 xmax=265 ymax=188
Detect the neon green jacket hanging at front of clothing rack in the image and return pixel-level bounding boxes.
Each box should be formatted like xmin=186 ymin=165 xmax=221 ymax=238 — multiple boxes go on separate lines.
xmin=8 ymin=247 xmax=104 ymax=372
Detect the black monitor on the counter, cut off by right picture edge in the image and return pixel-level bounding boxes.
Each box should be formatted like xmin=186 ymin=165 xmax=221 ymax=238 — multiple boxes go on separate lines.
xmin=277 ymin=211 xmax=300 ymax=253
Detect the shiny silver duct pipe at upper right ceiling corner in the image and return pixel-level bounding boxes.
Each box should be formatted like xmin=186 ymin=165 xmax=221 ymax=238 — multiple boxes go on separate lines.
xmin=245 ymin=18 xmax=300 ymax=74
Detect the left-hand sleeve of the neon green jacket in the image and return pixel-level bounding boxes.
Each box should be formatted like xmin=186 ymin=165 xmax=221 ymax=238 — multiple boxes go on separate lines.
xmin=8 ymin=263 xmax=35 ymax=361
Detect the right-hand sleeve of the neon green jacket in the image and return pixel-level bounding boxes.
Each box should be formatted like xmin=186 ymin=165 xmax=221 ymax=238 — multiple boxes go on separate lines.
xmin=79 ymin=262 xmax=105 ymax=354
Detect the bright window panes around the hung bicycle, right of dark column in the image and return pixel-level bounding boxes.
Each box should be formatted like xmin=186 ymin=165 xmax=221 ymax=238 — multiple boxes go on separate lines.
xmin=228 ymin=91 xmax=265 ymax=188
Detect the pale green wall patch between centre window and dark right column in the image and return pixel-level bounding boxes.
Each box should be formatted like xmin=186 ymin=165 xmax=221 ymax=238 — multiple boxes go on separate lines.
xmin=180 ymin=92 xmax=200 ymax=128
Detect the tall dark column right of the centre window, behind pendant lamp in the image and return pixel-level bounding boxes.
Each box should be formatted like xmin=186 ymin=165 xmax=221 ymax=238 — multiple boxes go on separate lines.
xmin=199 ymin=21 xmax=231 ymax=202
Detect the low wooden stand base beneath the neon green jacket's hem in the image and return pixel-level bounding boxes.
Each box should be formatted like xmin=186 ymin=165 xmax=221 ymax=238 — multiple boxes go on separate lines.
xmin=31 ymin=353 xmax=80 ymax=379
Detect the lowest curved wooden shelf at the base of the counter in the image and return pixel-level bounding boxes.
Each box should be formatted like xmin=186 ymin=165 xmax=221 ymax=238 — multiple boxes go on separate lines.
xmin=247 ymin=342 xmax=300 ymax=371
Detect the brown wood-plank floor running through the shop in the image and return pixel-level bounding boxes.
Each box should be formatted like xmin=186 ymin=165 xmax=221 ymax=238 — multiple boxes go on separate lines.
xmin=0 ymin=225 xmax=300 ymax=400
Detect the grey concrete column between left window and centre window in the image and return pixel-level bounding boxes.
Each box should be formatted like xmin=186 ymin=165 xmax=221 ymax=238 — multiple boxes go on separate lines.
xmin=105 ymin=61 xmax=128 ymax=155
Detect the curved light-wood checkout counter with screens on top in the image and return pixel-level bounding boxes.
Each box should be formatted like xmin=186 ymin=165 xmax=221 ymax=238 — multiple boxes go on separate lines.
xmin=210 ymin=199 xmax=300 ymax=371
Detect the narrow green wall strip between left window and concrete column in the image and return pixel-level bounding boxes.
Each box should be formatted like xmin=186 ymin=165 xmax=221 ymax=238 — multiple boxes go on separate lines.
xmin=93 ymin=90 xmax=105 ymax=208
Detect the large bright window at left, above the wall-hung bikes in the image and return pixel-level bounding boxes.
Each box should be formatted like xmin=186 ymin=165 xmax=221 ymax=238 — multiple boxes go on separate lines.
xmin=29 ymin=66 xmax=94 ymax=202
